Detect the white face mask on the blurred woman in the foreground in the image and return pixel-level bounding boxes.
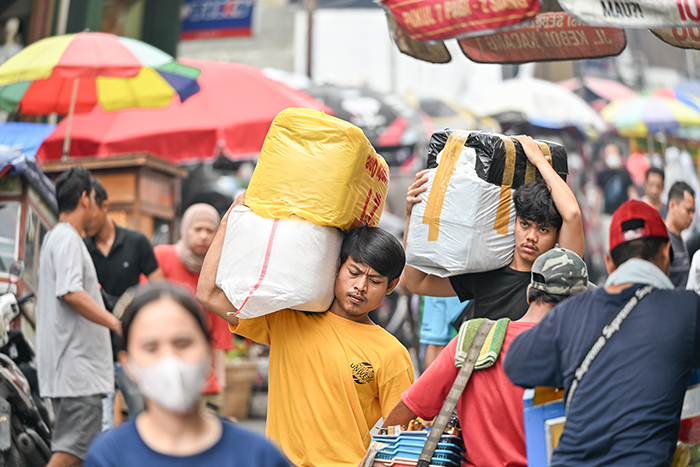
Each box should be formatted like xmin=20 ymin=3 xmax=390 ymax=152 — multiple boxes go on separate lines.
xmin=129 ymin=357 xmax=211 ymax=413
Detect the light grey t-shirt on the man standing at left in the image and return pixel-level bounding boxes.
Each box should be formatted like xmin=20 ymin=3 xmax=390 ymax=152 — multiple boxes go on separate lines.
xmin=36 ymin=222 xmax=114 ymax=397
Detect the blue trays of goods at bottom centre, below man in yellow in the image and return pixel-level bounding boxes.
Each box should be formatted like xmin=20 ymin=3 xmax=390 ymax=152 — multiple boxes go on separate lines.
xmin=372 ymin=421 xmax=465 ymax=467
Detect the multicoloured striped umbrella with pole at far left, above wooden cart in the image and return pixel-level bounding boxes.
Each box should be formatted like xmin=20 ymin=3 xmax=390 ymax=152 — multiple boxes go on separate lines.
xmin=0 ymin=32 xmax=200 ymax=156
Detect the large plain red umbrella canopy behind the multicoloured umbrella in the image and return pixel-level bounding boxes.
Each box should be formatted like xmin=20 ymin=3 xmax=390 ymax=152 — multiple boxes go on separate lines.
xmin=37 ymin=60 xmax=331 ymax=164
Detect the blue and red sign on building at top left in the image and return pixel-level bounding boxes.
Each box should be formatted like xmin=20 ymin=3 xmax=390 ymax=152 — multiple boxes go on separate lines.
xmin=180 ymin=0 xmax=254 ymax=39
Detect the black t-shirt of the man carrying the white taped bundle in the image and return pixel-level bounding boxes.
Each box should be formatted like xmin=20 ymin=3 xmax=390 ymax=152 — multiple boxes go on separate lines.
xmin=450 ymin=266 xmax=530 ymax=321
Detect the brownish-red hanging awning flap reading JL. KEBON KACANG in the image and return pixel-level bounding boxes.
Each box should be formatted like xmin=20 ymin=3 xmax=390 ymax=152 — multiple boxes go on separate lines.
xmin=459 ymin=13 xmax=627 ymax=63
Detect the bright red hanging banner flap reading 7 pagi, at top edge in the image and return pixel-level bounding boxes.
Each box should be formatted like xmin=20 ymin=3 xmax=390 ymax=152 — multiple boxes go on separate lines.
xmin=382 ymin=0 xmax=540 ymax=41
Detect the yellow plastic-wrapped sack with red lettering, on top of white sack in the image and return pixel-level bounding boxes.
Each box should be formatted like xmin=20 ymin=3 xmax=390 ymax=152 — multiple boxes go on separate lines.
xmin=246 ymin=109 xmax=389 ymax=230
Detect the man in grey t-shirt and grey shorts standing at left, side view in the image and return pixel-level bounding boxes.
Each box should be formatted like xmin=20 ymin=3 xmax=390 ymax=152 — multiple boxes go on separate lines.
xmin=36 ymin=167 xmax=121 ymax=467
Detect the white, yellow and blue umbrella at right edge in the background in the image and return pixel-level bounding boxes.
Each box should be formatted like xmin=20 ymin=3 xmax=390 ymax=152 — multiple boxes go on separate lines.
xmin=600 ymin=95 xmax=700 ymax=137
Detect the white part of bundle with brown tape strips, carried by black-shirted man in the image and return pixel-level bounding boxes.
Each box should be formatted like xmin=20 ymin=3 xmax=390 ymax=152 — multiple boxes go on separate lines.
xmin=406 ymin=148 xmax=515 ymax=277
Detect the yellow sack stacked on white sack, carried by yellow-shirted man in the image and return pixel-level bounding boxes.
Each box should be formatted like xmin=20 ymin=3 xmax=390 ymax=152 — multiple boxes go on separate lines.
xmin=216 ymin=109 xmax=389 ymax=318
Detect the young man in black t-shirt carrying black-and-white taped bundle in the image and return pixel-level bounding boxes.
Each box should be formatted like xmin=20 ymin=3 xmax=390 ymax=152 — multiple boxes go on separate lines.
xmin=404 ymin=136 xmax=584 ymax=320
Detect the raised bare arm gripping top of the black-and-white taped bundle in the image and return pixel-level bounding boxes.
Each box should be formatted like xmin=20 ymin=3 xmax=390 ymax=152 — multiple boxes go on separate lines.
xmin=513 ymin=135 xmax=585 ymax=258
